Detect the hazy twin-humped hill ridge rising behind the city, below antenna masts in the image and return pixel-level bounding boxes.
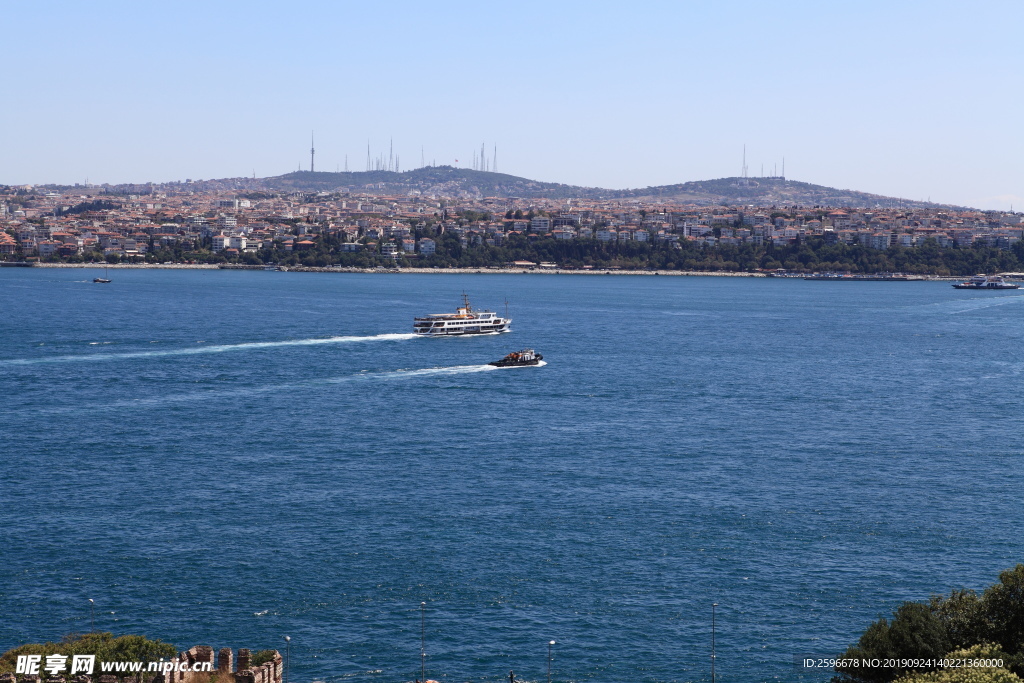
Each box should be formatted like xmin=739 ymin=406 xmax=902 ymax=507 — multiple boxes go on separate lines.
xmin=253 ymin=166 xmax=956 ymax=208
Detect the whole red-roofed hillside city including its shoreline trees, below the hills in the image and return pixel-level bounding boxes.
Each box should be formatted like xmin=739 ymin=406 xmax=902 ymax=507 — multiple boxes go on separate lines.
xmin=0 ymin=174 xmax=1024 ymax=274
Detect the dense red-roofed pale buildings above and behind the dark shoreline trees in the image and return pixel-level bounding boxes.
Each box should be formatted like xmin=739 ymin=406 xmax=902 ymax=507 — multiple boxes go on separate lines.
xmin=0 ymin=185 xmax=1024 ymax=274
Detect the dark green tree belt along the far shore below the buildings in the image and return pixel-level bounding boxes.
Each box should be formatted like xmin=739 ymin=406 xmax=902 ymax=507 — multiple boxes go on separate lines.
xmin=12 ymin=228 xmax=1024 ymax=276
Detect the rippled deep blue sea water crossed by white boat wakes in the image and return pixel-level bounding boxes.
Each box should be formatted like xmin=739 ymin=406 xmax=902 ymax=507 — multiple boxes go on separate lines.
xmin=0 ymin=269 xmax=1024 ymax=683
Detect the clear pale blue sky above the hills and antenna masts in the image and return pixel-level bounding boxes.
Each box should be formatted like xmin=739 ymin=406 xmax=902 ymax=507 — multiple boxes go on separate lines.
xmin=0 ymin=0 xmax=1024 ymax=210
